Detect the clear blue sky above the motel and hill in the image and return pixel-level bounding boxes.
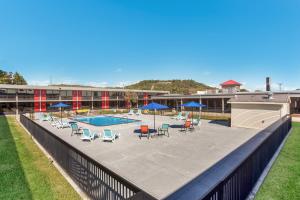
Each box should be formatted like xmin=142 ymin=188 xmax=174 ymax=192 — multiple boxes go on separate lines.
xmin=0 ymin=0 xmax=300 ymax=90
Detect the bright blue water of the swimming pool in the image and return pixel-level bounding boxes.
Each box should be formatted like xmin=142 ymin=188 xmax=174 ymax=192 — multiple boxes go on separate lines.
xmin=75 ymin=116 xmax=137 ymax=126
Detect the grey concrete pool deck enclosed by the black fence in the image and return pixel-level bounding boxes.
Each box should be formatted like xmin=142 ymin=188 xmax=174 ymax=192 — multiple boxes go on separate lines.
xmin=36 ymin=115 xmax=257 ymax=199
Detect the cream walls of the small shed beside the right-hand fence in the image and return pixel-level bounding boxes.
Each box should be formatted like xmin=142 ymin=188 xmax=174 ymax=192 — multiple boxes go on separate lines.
xmin=231 ymin=103 xmax=289 ymax=129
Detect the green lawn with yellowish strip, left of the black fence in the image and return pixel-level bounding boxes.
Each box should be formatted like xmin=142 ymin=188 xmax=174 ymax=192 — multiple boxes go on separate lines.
xmin=0 ymin=116 xmax=80 ymax=199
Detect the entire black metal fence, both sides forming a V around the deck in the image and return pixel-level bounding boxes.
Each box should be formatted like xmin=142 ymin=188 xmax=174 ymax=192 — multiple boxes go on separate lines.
xmin=20 ymin=115 xmax=291 ymax=200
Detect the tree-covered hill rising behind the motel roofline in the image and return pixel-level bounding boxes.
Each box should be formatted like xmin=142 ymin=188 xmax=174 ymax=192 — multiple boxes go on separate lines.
xmin=125 ymin=80 xmax=212 ymax=94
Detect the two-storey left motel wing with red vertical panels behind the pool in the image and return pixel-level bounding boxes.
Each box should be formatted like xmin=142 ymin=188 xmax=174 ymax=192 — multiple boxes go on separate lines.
xmin=0 ymin=84 xmax=169 ymax=114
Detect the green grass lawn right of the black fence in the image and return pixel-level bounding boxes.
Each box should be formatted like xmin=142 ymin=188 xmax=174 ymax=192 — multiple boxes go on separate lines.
xmin=255 ymin=123 xmax=300 ymax=200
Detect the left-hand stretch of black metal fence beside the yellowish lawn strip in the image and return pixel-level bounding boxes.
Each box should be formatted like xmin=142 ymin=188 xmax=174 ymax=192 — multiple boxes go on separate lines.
xmin=20 ymin=115 xmax=154 ymax=200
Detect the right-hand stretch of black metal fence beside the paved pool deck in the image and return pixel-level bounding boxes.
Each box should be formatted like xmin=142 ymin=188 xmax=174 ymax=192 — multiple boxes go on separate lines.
xmin=166 ymin=116 xmax=291 ymax=200
